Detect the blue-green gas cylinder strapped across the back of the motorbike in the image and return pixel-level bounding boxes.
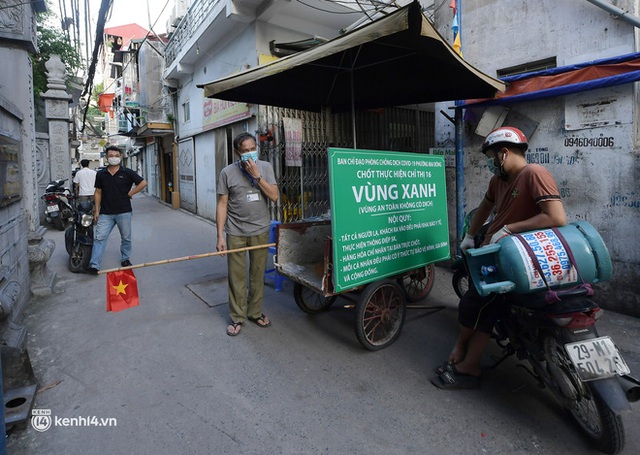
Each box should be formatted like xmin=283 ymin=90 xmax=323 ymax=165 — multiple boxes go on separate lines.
xmin=466 ymin=221 xmax=613 ymax=296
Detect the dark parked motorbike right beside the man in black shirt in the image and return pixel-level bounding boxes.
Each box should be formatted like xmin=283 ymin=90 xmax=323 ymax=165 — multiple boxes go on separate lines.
xmin=64 ymin=202 xmax=93 ymax=273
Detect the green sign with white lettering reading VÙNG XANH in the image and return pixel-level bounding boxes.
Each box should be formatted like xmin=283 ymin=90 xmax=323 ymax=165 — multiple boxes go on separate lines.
xmin=329 ymin=148 xmax=450 ymax=292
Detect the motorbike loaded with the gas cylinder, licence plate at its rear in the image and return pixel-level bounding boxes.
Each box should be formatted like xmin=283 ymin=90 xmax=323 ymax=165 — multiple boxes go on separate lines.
xmin=454 ymin=220 xmax=640 ymax=454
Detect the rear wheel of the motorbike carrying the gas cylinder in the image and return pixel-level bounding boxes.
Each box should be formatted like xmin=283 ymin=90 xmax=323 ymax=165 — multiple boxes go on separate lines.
xmin=545 ymin=336 xmax=625 ymax=454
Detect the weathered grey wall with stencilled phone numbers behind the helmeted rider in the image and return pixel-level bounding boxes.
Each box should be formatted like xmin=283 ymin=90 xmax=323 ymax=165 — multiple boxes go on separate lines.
xmin=437 ymin=0 xmax=640 ymax=316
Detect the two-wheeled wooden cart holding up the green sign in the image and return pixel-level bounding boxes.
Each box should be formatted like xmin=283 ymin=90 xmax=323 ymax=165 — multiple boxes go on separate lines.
xmin=274 ymin=220 xmax=435 ymax=351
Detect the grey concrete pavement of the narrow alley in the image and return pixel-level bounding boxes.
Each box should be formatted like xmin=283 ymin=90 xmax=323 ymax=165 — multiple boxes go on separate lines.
xmin=7 ymin=195 xmax=640 ymax=454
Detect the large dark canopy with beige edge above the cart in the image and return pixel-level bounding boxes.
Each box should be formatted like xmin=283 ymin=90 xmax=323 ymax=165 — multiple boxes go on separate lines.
xmin=198 ymin=2 xmax=505 ymax=112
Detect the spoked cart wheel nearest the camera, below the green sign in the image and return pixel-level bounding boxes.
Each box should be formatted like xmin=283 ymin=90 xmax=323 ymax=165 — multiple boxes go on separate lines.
xmin=355 ymin=280 xmax=406 ymax=351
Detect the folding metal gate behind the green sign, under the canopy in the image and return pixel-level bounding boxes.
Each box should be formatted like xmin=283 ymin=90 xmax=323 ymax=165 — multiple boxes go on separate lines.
xmin=258 ymin=106 xmax=435 ymax=222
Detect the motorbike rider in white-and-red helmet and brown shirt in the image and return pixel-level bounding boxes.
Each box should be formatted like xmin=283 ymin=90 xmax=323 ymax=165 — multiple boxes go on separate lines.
xmin=431 ymin=126 xmax=566 ymax=390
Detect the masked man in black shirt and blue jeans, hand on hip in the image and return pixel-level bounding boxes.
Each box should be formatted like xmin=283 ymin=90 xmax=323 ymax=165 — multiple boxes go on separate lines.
xmin=87 ymin=145 xmax=147 ymax=275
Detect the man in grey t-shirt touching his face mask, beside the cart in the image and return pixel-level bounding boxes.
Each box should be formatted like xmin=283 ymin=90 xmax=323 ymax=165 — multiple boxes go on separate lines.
xmin=216 ymin=133 xmax=280 ymax=336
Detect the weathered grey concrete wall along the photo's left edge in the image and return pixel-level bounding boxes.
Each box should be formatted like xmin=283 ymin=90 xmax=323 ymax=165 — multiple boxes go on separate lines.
xmin=0 ymin=4 xmax=40 ymax=347
